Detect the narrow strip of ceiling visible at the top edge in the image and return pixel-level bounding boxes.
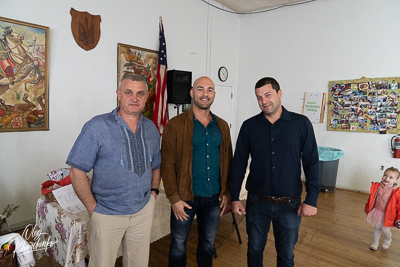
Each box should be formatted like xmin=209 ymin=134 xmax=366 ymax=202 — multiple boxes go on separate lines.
xmin=215 ymin=0 xmax=310 ymax=13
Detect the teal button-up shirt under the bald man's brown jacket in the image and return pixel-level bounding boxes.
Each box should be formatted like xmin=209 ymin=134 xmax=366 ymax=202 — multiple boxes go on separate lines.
xmin=192 ymin=114 xmax=222 ymax=197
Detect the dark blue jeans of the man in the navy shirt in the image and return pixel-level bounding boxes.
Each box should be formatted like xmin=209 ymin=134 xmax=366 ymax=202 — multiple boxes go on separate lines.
xmin=246 ymin=193 xmax=301 ymax=267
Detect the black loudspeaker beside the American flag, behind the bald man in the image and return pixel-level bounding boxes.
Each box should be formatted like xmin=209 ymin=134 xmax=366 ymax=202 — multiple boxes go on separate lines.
xmin=167 ymin=70 xmax=192 ymax=104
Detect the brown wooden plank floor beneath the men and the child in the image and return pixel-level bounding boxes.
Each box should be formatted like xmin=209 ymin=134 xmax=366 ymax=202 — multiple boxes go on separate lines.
xmin=28 ymin=189 xmax=400 ymax=267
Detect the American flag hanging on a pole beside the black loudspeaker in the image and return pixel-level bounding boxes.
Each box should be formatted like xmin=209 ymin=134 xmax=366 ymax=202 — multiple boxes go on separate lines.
xmin=153 ymin=17 xmax=168 ymax=134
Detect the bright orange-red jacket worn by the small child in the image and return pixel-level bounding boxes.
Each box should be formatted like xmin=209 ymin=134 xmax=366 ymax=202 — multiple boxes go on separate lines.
xmin=365 ymin=182 xmax=400 ymax=227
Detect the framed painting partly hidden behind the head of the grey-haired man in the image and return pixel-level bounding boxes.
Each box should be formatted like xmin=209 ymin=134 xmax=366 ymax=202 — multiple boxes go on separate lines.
xmin=117 ymin=43 xmax=158 ymax=120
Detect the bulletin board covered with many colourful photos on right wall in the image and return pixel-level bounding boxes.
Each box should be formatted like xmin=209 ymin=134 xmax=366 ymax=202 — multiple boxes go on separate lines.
xmin=327 ymin=77 xmax=400 ymax=134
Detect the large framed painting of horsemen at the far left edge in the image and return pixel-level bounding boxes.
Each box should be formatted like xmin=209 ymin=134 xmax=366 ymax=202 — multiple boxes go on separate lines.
xmin=0 ymin=17 xmax=50 ymax=132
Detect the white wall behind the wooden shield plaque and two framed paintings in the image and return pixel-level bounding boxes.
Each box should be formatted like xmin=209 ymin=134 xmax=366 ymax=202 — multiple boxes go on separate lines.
xmin=0 ymin=0 xmax=239 ymax=226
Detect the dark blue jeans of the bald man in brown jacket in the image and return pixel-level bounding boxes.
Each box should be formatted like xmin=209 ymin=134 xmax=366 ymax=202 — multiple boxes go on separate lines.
xmin=169 ymin=195 xmax=219 ymax=267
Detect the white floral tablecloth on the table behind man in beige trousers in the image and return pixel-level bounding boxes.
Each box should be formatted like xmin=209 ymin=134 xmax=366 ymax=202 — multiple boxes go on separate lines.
xmin=36 ymin=194 xmax=171 ymax=267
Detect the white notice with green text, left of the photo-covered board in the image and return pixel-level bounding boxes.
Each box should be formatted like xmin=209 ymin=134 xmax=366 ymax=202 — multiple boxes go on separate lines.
xmin=303 ymin=92 xmax=326 ymax=123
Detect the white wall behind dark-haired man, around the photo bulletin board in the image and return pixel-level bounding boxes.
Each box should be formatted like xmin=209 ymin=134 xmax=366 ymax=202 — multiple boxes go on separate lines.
xmin=236 ymin=0 xmax=400 ymax=192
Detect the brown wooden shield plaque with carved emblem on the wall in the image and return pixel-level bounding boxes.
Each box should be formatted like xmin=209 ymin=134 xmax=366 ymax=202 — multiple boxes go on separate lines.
xmin=70 ymin=8 xmax=101 ymax=51
